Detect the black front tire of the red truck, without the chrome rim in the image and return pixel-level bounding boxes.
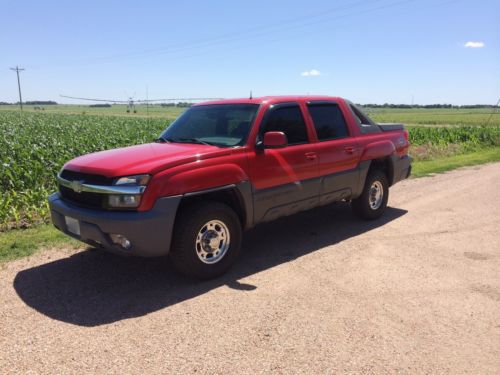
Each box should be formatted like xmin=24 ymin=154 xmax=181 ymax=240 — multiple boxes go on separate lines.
xmin=170 ymin=202 xmax=242 ymax=279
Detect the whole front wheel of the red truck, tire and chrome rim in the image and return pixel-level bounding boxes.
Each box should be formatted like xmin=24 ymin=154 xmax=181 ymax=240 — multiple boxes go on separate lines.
xmin=170 ymin=202 xmax=241 ymax=279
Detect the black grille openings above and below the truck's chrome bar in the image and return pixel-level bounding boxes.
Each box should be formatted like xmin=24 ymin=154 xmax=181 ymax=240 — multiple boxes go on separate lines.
xmin=59 ymin=169 xmax=113 ymax=208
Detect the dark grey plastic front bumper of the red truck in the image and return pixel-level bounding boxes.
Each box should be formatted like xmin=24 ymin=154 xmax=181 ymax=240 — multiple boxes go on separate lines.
xmin=49 ymin=193 xmax=181 ymax=257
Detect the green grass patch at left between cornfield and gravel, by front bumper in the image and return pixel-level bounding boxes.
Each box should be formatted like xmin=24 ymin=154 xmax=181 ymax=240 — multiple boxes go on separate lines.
xmin=0 ymin=224 xmax=85 ymax=263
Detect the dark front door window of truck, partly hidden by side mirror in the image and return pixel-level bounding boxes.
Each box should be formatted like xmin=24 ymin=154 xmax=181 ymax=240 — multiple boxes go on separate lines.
xmin=262 ymin=105 xmax=308 ymax=145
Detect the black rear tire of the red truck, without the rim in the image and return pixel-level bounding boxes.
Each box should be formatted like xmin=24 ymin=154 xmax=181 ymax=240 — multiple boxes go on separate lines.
xmin=351 ymin=169 xmax=389 ymax=220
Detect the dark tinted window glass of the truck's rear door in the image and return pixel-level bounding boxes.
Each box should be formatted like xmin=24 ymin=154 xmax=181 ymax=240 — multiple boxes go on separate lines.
xmin=307 ymin=103 xmax=349 ymax=141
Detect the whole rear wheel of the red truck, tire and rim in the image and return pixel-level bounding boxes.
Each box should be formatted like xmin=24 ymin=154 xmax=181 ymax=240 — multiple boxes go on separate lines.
xmin=351 ymin=170 xmax=389 ymax=220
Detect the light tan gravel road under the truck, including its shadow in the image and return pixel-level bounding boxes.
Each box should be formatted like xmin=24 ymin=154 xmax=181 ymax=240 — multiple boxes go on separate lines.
xmin=0 ymin=163 xmax=500 ymax=374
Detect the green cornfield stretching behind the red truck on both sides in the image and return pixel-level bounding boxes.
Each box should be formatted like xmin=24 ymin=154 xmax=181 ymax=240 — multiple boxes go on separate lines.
xmin=0 ymin=110 xmax=500 ymax=230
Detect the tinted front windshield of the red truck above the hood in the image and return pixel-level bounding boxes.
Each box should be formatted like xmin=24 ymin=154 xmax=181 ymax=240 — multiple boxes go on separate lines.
xmin=159 ymin=104 xmax=259 ymax=147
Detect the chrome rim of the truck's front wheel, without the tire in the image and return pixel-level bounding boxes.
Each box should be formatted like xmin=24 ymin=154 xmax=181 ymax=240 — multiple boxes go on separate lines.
xmin=195 ymin=220 xmax=231 ymax=264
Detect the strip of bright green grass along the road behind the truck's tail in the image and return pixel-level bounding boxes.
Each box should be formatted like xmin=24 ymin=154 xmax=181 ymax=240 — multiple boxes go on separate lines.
xmin=412 ymin=147 xmax=500 ymax=177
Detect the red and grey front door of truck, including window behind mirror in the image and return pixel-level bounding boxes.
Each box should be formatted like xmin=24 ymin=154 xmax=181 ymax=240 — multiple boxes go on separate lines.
xmin=249 ymin=103 xmax=319 ymax=223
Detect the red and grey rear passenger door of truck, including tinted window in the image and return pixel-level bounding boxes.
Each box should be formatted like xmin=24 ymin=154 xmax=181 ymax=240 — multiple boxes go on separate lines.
xmin=307 ymin=101 xmax=360 ymax=204
